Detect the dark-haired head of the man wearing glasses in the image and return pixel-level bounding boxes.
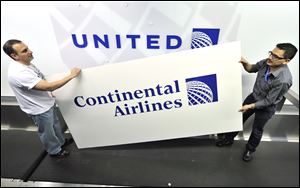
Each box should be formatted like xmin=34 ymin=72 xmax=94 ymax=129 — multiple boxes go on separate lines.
xmin=267 ymin=43 xmax=298 ymax=67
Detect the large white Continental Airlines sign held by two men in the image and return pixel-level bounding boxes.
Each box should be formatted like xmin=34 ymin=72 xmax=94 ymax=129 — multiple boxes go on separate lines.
xmin=50 ymin=42 xmax=242 ymax=148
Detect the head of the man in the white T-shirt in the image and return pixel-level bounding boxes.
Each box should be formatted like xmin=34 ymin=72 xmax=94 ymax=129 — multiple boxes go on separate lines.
xmin=3 ymin=39 xmax=33 ymax=64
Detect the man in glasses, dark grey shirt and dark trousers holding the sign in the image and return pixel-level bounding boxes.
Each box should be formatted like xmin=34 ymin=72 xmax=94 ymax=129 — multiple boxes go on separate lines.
xmin=216 ymin=43 xmax=298 ymax=161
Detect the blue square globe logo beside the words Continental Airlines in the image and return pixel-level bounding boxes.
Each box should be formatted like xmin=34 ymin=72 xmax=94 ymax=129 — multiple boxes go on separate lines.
xmin=186 ymin=74 xmax=218 ymax=106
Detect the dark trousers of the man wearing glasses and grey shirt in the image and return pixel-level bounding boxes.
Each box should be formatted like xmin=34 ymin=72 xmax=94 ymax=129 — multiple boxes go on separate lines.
xmin=225 ymin=93 xmax=276 ymax=152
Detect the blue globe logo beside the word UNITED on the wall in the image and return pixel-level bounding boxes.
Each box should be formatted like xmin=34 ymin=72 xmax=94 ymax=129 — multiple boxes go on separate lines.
xmin=191 ymin=28 xmax=220 ymax=49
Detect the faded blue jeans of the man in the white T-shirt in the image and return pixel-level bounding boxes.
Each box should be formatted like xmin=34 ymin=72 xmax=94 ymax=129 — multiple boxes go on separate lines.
xmin=29 ymin=105 xmax=65 ymax=155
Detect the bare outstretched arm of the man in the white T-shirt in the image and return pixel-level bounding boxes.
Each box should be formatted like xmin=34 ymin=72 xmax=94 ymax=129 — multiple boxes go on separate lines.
xmin=33 ymin=68 xmax=81 ymax=91
